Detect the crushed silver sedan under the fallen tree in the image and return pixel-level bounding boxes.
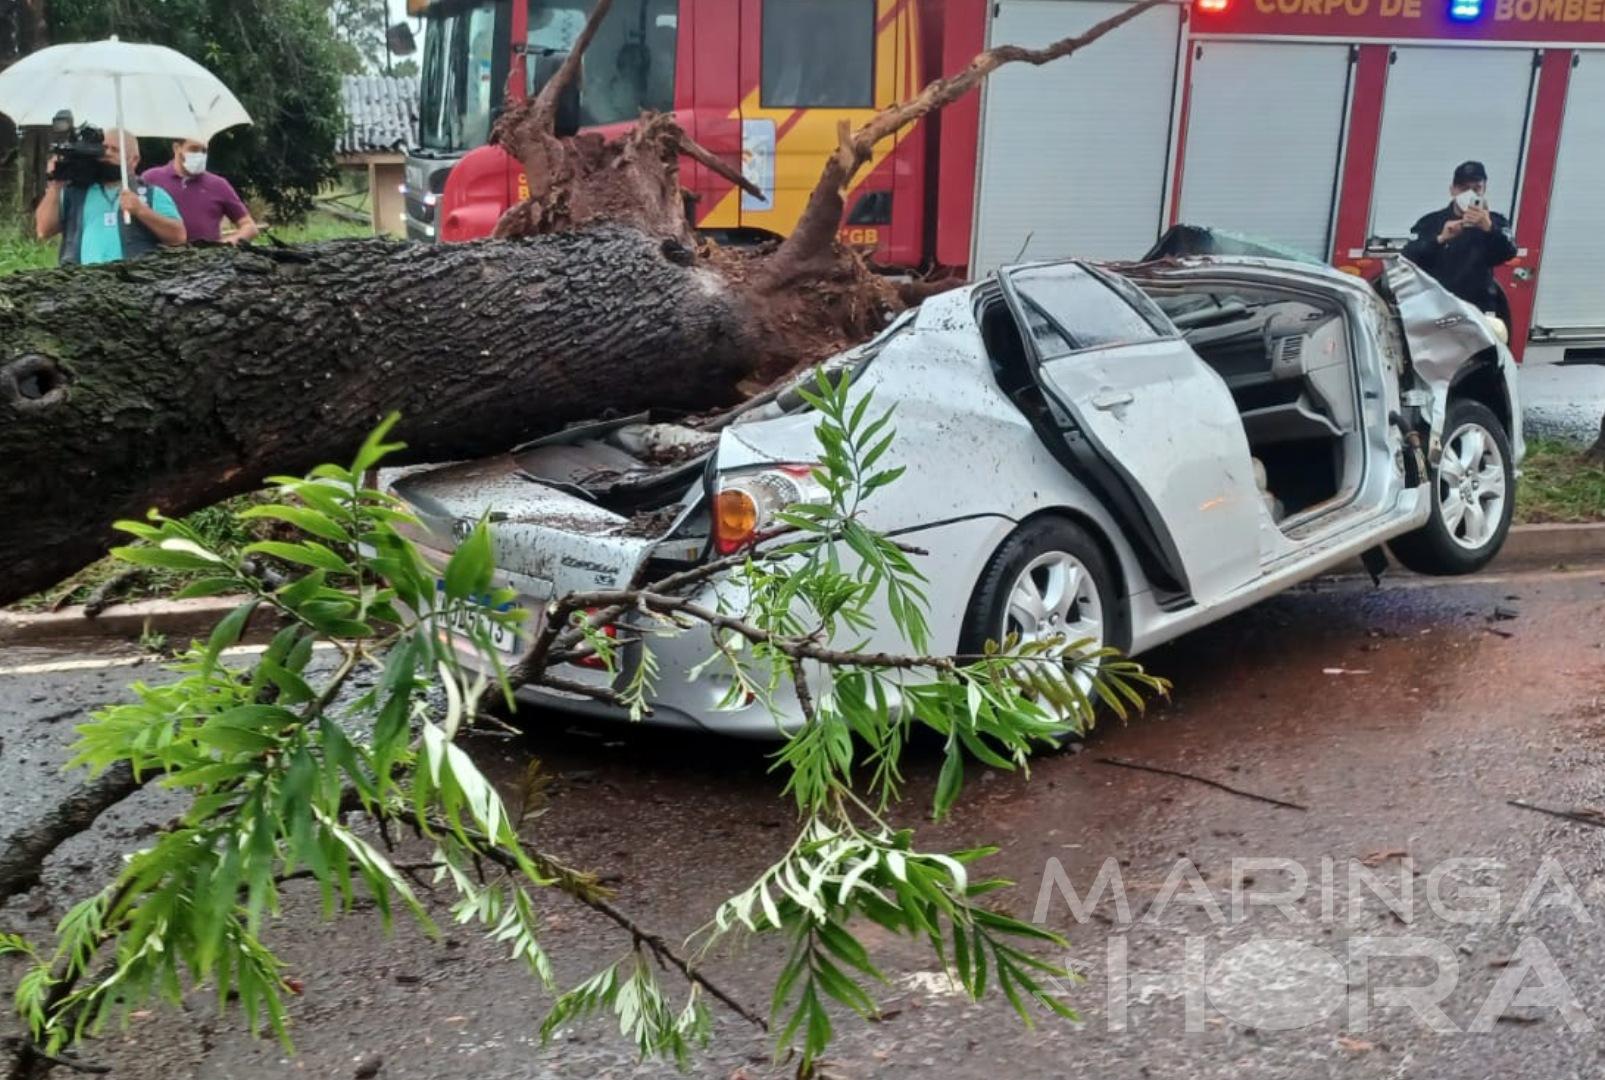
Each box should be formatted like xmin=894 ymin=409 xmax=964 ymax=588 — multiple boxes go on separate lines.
xmin=387 ymin=257 xmax=1523 ymax=737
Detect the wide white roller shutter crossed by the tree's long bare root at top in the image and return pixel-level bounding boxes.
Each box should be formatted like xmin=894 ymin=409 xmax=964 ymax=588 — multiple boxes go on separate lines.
xmin=973 ymin=0 xmax=1181 ymax=273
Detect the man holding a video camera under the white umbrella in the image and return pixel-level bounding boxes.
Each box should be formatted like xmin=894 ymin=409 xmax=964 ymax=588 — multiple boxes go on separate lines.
xmin=34 ymin=130 xmax=185 ymax=266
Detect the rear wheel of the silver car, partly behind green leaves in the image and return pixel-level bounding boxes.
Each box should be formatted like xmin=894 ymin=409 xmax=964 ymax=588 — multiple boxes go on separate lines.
xmin=958 ymin=517 xmax=1132 ymax=702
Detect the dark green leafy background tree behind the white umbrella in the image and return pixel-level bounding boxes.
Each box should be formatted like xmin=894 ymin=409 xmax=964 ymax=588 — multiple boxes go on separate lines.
xmin=50 ymin=0 xmax=348 ymax=220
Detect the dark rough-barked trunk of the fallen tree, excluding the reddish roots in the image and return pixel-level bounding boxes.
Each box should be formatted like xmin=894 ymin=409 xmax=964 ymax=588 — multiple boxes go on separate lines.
xmin=0 ymin=228 xmax=758 ymax=602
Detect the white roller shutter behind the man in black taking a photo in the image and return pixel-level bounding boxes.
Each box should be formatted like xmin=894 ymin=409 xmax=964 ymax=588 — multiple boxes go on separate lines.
xmin=1369 ymin=45 xmax=1536 ymax=244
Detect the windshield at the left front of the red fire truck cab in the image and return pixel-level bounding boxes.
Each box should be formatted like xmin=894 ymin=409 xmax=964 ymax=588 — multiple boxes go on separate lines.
xmin=419 ymin=3 xmax=504 ymax=154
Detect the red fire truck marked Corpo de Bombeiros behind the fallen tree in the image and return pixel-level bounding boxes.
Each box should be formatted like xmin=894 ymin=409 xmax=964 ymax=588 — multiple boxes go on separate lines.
xmin=408 ymin=0 xmax=1605 ymax=362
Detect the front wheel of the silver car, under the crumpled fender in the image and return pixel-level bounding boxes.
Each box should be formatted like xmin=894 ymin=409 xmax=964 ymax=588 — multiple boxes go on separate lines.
xmin=1388 ymin=398 xmax=1515 ymax=576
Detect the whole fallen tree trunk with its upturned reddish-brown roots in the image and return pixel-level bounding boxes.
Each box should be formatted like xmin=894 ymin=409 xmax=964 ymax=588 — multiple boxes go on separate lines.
xmin=0 ymin=0 xmax=1168 ymax=603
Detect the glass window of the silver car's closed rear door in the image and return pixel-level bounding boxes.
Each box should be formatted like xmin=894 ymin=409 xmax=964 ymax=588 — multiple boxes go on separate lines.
xmin=1010 ymin=263 xmax=1164 ymax=359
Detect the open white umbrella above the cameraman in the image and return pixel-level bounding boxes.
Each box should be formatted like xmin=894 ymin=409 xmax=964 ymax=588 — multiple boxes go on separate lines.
xmin=0 ymin=37 xmax=250 ymax=202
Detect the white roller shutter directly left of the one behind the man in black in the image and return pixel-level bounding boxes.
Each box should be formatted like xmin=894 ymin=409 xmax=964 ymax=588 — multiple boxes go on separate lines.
xmin=1180 ymin=42 xmax=1350 ymax=260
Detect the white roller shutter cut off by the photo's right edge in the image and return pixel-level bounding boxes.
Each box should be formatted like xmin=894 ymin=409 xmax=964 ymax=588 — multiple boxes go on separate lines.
xmin=1533 ymin=50 xmax=1605 ymax=330
